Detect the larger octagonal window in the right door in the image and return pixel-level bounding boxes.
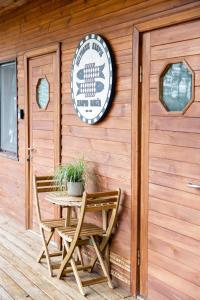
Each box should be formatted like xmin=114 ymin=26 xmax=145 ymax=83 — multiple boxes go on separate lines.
xmin=160 ymin=62 xmax=193 ymax=112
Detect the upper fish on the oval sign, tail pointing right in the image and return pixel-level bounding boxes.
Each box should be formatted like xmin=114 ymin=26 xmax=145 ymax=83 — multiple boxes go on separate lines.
xmin=77 ymin=63 xmax=105 ymax=81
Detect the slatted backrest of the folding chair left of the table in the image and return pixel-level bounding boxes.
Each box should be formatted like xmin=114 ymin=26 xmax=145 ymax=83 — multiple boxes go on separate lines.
xmin=33 ymin=175 xmax=64 ymax=222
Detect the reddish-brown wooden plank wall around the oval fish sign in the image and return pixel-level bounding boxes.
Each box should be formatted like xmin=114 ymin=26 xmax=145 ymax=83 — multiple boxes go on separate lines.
xmin=0 ymin=0 xmax=199 ymax=285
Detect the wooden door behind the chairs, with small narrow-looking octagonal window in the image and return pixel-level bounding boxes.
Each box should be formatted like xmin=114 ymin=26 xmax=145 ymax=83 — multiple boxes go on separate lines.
xmin=27 ymin=45 xmax=60 ymax=230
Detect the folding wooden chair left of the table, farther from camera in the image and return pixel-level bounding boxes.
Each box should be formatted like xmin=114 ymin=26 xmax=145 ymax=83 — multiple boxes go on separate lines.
xmin=33 ymin=175 xmax=65 ymax=276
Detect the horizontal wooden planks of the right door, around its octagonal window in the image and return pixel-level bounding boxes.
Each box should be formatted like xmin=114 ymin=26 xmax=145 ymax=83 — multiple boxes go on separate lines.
xmin=145 ymin=20 xmax=200 ymax=300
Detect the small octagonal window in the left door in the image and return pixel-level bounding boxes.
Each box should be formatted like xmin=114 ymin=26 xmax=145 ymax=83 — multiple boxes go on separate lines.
xmin=36 ymin=78 xmax=49 ymax=109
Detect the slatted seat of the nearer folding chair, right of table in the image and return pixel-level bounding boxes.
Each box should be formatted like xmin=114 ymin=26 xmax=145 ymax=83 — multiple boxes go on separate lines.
xmin=57 ymin=223 xmax=105 ymax=241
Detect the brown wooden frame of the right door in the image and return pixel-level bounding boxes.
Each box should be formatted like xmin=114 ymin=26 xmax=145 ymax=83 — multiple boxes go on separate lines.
xmin=131 ymin=3 xmax=200 ymax=299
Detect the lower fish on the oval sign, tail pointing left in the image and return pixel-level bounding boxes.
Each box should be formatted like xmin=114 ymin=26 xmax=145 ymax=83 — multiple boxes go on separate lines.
xmin=77 ymin=78 xmax=104 ymax=97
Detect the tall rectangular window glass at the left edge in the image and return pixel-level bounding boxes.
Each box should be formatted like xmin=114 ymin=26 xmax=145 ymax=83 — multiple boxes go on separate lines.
xmin=0 ymin=62 xmax=17 ymax=153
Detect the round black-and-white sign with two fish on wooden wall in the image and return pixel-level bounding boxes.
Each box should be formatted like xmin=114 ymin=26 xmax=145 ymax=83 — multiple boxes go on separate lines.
xmin=71 ymin=34 xmax=113 ymax=124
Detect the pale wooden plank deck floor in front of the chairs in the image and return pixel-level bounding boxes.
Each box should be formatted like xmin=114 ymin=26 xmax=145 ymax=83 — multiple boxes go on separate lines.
xmin=0 ymin=214 xmax=134 ymax=300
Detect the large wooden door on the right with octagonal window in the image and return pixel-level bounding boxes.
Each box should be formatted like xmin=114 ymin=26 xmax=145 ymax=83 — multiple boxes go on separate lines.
xmin=140 ymin=21 xmax=200 ymax=300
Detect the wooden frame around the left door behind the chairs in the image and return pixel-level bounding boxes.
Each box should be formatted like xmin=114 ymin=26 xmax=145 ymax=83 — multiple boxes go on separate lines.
xmin=24 ymin=43 xmax=61 ymax=229
